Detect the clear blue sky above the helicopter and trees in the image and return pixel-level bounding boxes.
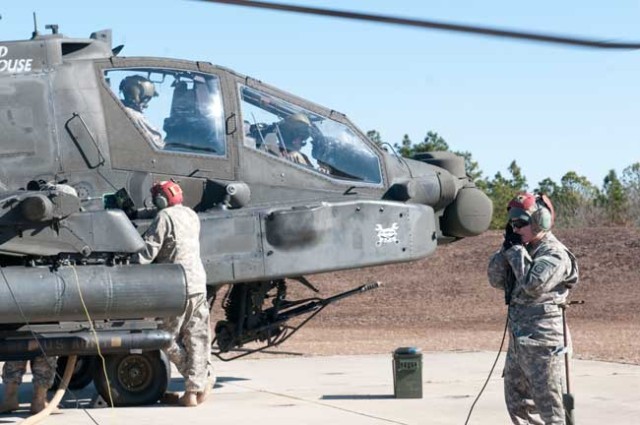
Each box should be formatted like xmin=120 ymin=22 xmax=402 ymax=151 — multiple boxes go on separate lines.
xmin=0 ymin=0 xmax=640 ymax=189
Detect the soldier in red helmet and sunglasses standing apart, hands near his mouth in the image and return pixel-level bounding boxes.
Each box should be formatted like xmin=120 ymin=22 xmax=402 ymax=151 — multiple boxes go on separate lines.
xmin=488 ymin=193 xmax=578 ymax=425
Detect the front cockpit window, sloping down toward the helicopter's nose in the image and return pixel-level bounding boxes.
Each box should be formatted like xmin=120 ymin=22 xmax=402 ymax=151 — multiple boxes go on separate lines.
xmin=240 ymin=86 xmax=382 ymax=184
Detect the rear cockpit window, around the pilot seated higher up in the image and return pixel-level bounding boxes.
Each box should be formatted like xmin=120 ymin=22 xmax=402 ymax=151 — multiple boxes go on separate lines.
xmin=104 ymin=68 xmax=226 ymax=156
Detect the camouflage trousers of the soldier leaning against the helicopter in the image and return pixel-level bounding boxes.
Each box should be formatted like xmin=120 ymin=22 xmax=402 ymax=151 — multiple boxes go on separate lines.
xmin=160 ymin=294 xmax=211 ymax=392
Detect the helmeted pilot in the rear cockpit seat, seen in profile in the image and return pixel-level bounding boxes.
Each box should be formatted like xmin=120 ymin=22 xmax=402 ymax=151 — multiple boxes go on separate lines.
xmin=120 ymin=75 xmax=165 ymax=149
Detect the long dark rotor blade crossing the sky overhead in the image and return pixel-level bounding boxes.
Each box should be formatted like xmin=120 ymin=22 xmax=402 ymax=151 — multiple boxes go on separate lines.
xmin=199 ymin=0 xmax=640 ymax=50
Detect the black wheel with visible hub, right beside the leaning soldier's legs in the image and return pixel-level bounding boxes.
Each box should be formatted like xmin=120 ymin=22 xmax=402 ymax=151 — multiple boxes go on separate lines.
xmin=93 ymin=351 xmax=171 ymax=406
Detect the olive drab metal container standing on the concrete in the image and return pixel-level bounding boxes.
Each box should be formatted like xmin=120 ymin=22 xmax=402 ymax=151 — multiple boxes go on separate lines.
xmin=393 ymin=347 xmax=422 ymax=398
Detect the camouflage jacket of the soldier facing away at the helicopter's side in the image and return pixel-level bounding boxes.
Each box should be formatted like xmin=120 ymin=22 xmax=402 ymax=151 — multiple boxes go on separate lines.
xmin=138 ymin=205 xmax=207 ymax=295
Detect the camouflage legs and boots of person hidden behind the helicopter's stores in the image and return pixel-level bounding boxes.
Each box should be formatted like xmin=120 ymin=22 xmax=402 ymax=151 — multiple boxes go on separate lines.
xmin=0 ymin=356 xmax=56 ymax=414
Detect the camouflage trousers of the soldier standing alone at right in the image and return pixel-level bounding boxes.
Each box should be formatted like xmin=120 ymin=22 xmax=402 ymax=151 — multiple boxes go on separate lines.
xmin=504 ymin=335 xmax=565 ymax=425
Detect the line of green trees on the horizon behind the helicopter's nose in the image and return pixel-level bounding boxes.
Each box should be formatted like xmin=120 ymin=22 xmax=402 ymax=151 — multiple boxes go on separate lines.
xmin=367 ymin=130 xmax=640 ymax=229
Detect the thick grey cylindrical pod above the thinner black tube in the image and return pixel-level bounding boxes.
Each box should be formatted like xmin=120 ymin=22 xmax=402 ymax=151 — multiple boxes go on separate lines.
xmin=0 ymin=264 xmax=187 ymax=324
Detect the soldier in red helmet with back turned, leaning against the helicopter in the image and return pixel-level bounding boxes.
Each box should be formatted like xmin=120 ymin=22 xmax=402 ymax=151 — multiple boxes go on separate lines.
xmin=138 ymin=181 xmax=213 ymax=406
